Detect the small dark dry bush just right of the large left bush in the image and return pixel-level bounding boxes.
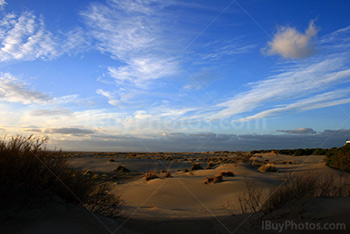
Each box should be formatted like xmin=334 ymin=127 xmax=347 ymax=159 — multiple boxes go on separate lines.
xmin=82 ymin=183 xmax=122 ymax=217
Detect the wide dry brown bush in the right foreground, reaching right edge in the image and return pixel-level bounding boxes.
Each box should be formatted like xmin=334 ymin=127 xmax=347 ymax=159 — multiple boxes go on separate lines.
xmin=237 ymin=172 xmax=350 ymax=214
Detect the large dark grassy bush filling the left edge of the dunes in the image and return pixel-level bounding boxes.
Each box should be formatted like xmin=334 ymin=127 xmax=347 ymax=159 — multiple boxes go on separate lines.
xmin=0 ymin=136 xmax=93 ymax=209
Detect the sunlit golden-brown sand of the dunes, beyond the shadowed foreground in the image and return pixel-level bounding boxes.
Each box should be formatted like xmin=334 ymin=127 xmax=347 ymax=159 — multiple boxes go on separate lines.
xmin=69 ymin=154 xmax=333 ymax=219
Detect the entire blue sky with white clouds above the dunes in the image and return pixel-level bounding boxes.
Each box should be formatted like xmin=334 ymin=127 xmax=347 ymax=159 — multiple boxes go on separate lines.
xmin=0 ymin=0 xmax=350 ymax=152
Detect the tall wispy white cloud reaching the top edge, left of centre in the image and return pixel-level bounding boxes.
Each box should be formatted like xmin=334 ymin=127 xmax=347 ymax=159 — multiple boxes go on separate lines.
xmin=82 ymin=0 xmax=177 ymax=87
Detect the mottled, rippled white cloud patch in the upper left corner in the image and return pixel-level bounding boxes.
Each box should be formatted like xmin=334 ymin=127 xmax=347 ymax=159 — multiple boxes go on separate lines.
xmin=0 ymin=10 xmax=91 ymax=62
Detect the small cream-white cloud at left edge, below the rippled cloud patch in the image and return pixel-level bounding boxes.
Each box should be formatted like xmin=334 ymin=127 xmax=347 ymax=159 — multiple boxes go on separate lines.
xmin=0 ymin=73 xmax=51 ymax=104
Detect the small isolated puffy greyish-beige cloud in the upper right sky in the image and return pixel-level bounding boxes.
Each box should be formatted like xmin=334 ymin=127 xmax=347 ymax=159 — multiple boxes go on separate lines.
xmin=262 ymin=21 xmax=318 ymax=59
